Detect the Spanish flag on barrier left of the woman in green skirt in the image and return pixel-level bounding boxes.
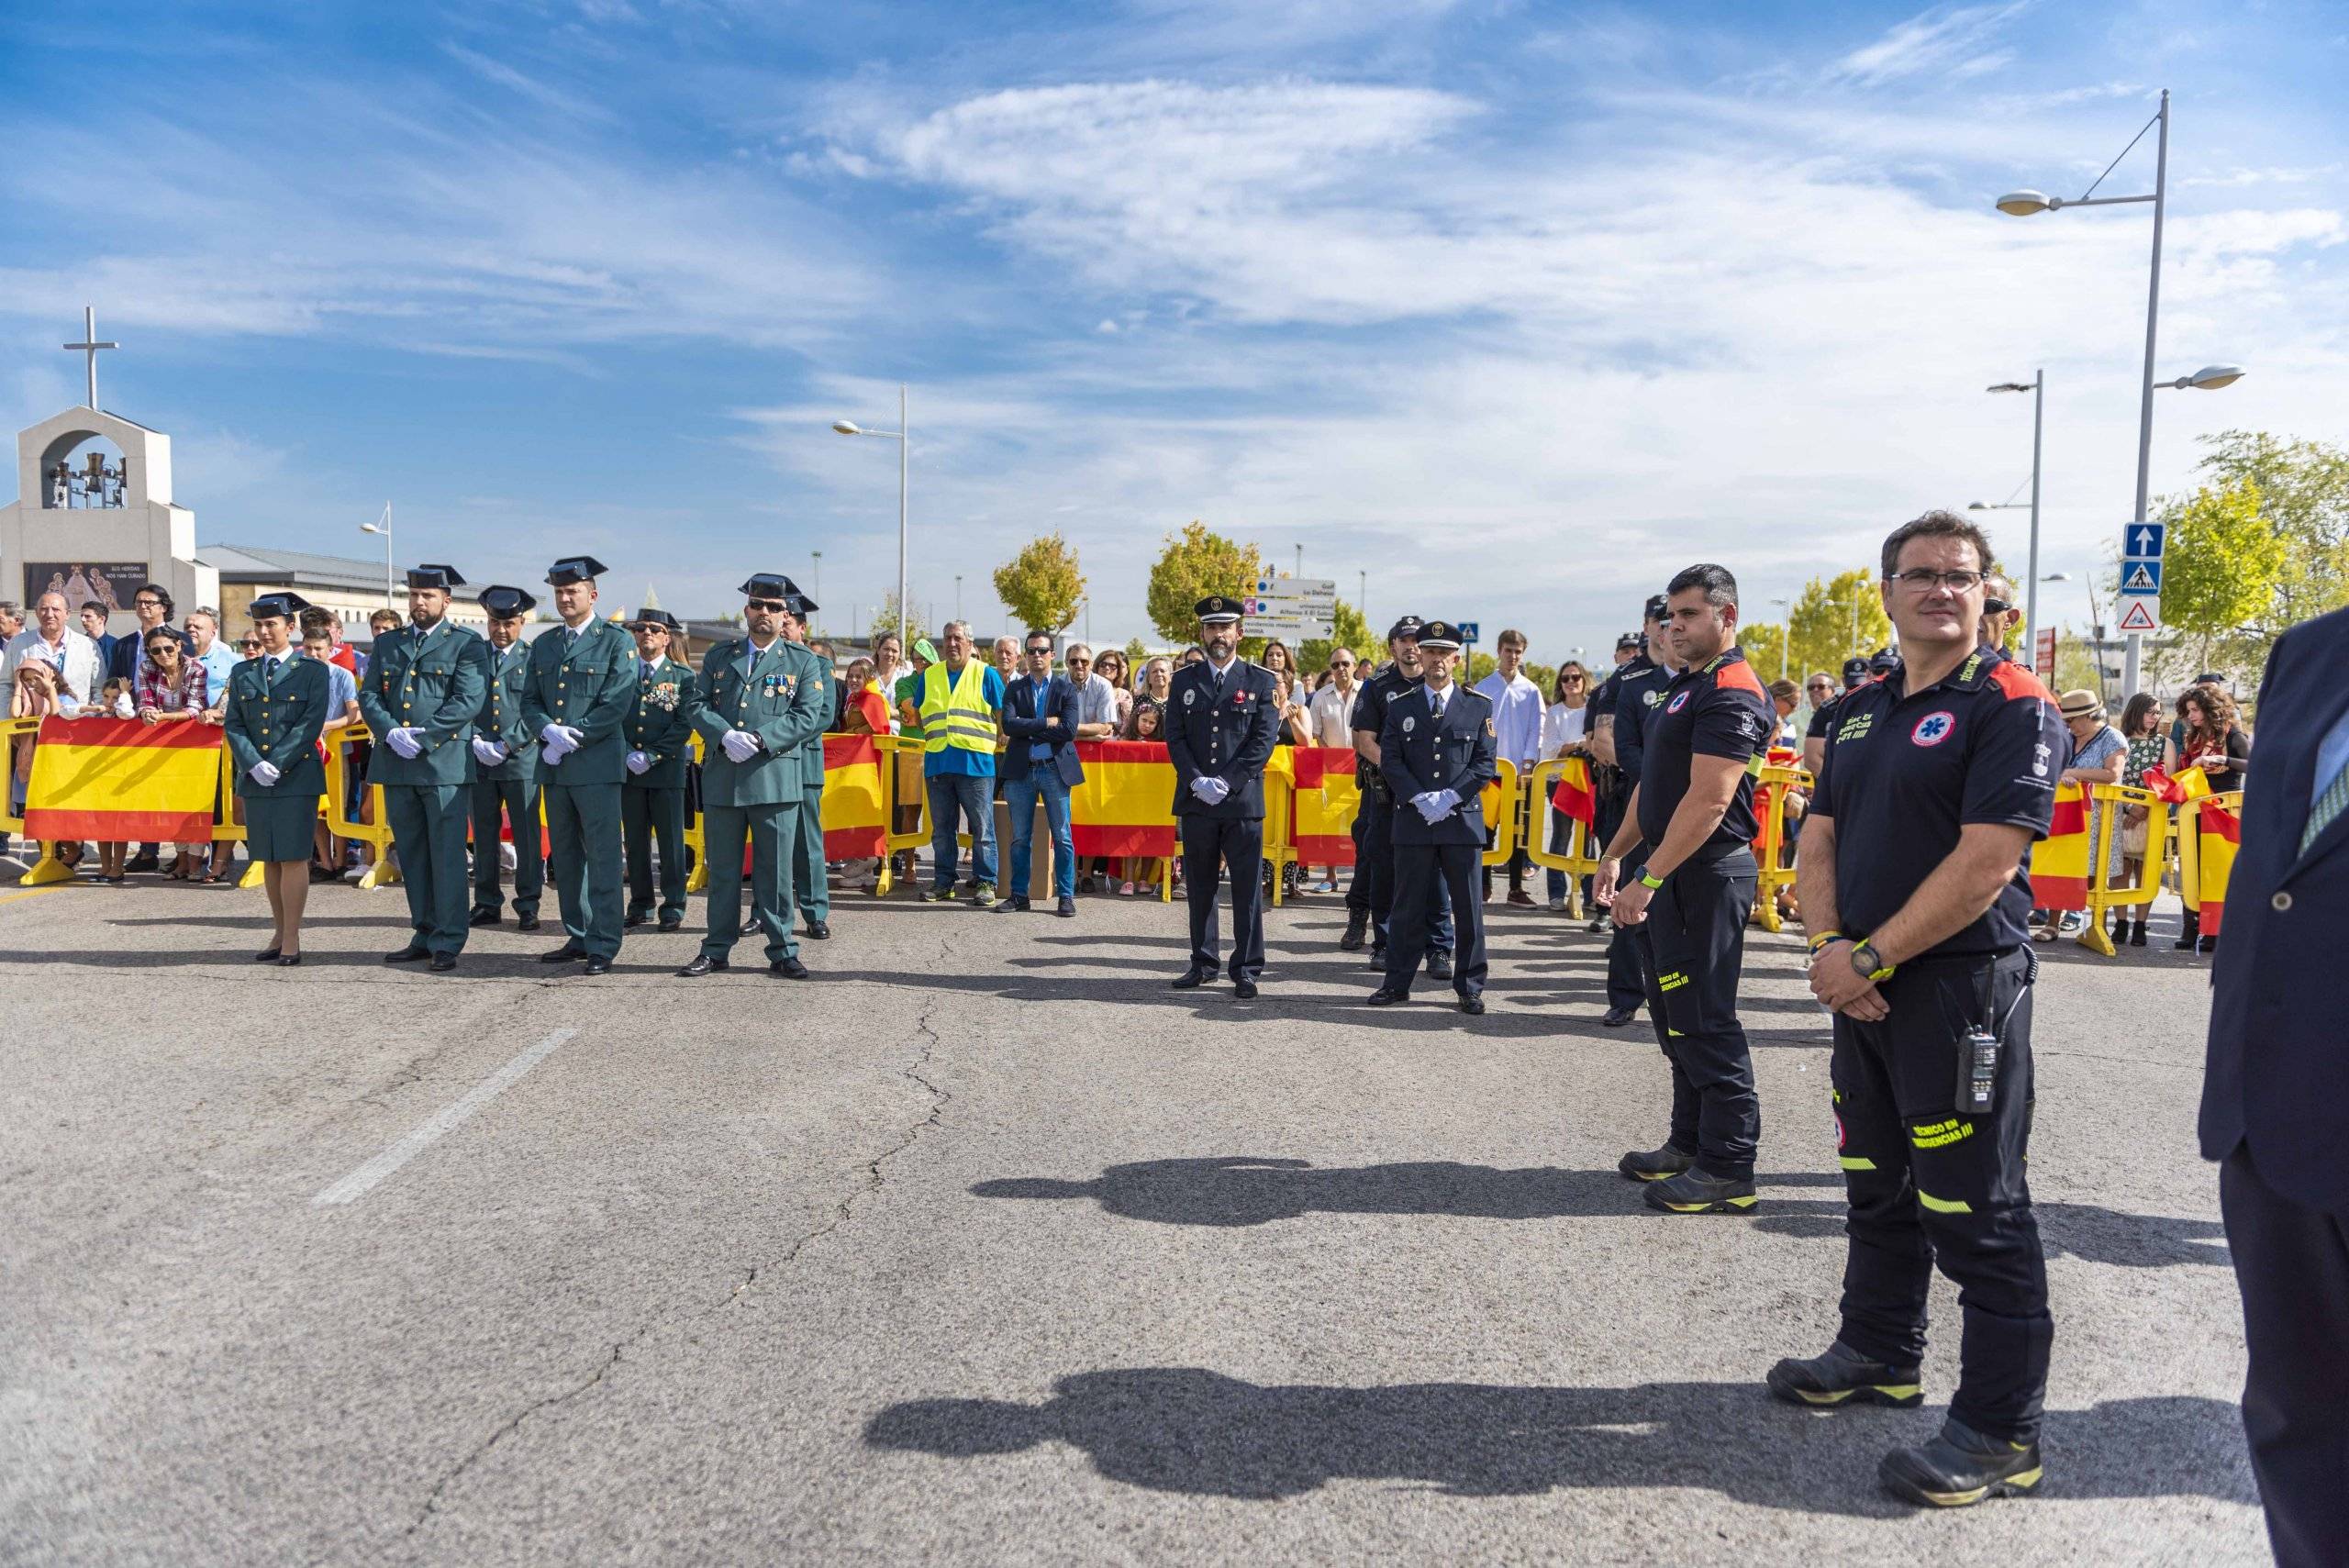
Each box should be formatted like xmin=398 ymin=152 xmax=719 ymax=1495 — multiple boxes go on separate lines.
xmin=24 ymin=718 xmax=221 ymax=842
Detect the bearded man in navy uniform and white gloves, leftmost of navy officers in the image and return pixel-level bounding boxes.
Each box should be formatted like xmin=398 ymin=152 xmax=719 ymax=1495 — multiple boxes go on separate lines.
xmin=1165 ymin=594 xmax=1280 ymax=1002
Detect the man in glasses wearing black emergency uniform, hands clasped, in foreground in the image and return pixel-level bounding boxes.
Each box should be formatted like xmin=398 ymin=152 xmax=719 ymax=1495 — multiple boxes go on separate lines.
xmin=1769 ymin=512 xmax=2069 ymax=1507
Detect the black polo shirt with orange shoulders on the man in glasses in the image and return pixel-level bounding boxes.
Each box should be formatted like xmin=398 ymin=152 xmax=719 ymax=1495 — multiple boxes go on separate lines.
xmin=1811 ymin=648 xmax=2072 ymax=958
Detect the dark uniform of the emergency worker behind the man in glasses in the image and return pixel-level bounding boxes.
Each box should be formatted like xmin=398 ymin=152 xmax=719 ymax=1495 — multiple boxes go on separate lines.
xmin=1616 ymin=648 xmax=1778 ymax=1183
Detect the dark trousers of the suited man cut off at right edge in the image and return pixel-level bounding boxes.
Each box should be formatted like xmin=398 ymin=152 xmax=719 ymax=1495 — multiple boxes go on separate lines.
xmin=2218 ymin=1143 xmax=2349 ymax=1568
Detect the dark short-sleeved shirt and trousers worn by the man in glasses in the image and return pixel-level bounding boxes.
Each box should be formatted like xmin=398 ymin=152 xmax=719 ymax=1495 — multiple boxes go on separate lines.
xmin=1811 ymin=648 xmax=2069 ymax=1443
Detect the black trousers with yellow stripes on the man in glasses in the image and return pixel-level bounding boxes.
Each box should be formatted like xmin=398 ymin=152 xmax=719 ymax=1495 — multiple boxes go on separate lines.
xmin=1828 ymin=949 xmax=2039 ymax=1445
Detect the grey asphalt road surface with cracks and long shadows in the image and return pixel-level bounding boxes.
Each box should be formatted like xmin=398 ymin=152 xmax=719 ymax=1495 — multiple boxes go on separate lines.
xmin=0 ymin=878 xmax=2265 ymax=1568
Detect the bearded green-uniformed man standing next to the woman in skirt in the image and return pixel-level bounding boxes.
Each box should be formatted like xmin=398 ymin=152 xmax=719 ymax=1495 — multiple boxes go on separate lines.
xmin=360 ymin=566 xmax=488 ymax=974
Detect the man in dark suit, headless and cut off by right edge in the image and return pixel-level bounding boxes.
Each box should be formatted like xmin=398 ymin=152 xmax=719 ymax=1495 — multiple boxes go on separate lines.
xmin=2201 ymin=594 xmax=2349 ymax=1568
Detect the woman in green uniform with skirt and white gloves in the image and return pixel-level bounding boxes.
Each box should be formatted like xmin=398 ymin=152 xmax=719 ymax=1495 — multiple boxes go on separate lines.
xmin=223 ymin=594 xmax=331 ymax=964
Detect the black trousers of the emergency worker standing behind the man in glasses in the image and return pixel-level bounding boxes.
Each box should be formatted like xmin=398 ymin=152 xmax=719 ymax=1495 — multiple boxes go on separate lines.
xmin=1626 ymin=850 xmax=1762 ymax=1178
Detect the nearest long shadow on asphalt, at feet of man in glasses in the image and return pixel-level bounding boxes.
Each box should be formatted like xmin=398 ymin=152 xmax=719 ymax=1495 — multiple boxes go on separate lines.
xmin=864 ymin=1366 xmax=2257 ymax=1517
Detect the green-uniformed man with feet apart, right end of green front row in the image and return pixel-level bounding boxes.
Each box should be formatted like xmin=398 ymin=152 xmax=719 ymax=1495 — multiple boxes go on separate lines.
xmin=679 ymin=573 xmax=831 ymax=979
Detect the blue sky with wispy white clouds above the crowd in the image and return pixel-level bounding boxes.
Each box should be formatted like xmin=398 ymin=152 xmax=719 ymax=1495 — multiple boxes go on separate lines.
xmin=0 ymin=0 xmax=2349 ymax=657
